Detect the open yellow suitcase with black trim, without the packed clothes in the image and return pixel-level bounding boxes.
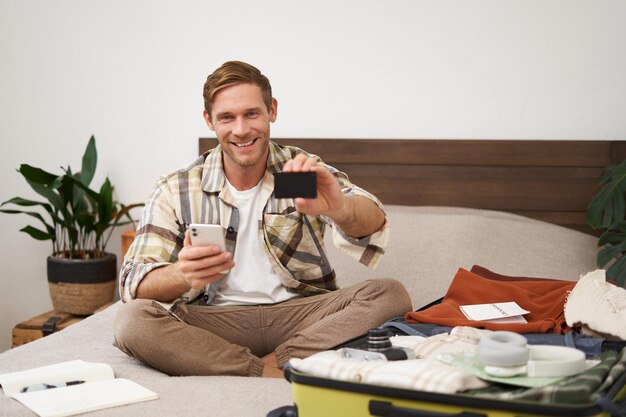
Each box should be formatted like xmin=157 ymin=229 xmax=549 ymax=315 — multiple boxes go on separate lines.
xmin=267 ymin=266 xmax=626 ymax=417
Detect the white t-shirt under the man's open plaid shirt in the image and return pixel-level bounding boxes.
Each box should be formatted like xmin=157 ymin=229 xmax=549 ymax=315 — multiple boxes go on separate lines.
xmin=211 ymin=181 xmax=299 ymax=305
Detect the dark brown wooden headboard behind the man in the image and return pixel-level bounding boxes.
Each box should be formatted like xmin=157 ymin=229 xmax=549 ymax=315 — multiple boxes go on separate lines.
xmin=199 ymin=138 xmax=626 ymax=233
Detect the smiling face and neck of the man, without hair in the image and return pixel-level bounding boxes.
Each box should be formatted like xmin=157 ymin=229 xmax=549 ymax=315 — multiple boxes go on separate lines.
xmin=204 ymin=83 xmax=277 ymax=180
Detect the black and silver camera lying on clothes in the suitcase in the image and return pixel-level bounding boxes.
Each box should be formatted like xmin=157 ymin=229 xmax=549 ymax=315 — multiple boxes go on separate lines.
xmin=341 ymin=327 xmax=415 ymax=361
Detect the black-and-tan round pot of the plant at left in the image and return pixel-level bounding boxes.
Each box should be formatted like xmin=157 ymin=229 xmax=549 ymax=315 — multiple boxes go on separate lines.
xmin=48 ymin=253 xmax=117 ymax=316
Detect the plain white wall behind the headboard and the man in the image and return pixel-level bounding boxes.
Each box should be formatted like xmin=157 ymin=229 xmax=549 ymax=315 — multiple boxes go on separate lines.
xmin=0 ymin=0 xmax=626 ymax=351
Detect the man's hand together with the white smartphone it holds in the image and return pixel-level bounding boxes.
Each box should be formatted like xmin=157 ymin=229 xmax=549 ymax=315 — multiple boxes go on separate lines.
xmin=178 ymin=224 xmax=235 ymax=289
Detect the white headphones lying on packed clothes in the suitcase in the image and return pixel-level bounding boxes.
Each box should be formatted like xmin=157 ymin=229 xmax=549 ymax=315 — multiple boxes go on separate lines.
xmin=478 ymin=331 xmax=585 ymax=377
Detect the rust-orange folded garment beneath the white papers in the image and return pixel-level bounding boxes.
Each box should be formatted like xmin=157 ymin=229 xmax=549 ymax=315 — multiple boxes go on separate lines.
xmin=404 ymin=268 xmax=576 ymax=334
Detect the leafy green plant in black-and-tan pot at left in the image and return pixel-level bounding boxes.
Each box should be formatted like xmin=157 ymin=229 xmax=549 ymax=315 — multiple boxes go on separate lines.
xmin=0 ymin=136 xmax=142 ymax=315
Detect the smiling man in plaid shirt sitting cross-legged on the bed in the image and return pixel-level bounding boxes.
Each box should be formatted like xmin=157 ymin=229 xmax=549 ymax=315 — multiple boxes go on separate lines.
xmin=115 ymin=61 xmax=411 ymax=377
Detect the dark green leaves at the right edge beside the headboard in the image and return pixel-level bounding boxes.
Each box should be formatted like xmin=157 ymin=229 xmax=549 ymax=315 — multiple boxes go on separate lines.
xmin=587 ymin=160 xmax=626 ymax=287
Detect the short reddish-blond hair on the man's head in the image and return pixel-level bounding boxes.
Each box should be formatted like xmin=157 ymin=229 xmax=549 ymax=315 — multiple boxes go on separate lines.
xmin=203 ymin=61 xmax=272 ymax=117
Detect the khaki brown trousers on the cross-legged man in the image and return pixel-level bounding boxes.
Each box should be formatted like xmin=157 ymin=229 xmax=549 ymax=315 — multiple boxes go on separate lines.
xmin=115 ymin=279 xmax=412 ymax=376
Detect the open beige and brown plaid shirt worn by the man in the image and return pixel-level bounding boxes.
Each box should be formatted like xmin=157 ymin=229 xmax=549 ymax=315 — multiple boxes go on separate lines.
xmin=120 ymin=142 xmax=389 ymax=304
